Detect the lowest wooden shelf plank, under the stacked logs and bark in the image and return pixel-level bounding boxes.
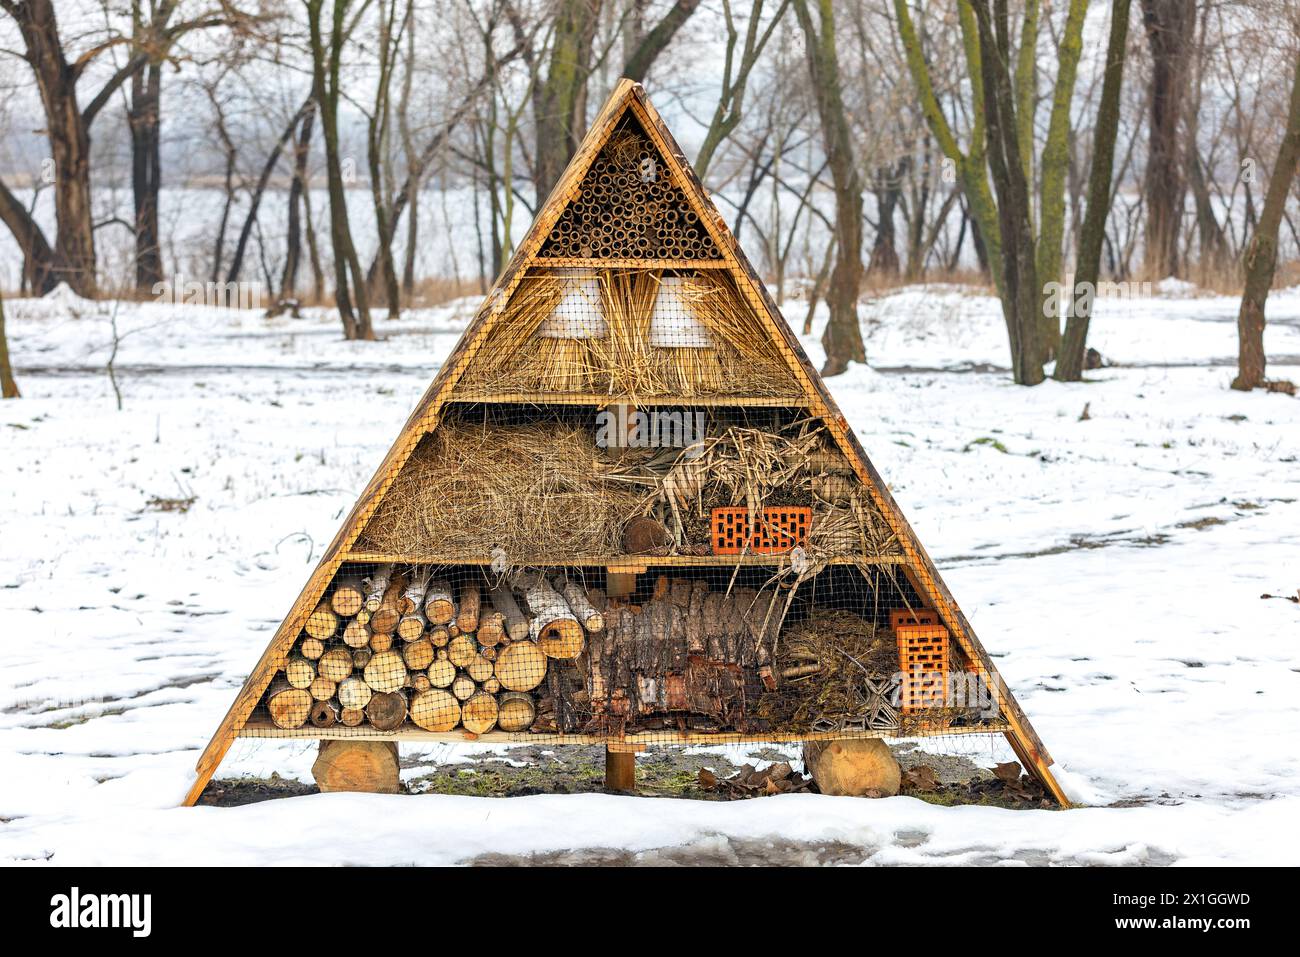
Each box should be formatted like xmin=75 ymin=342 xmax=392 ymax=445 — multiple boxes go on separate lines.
xmin=239 ymin=720 xmax=1006 ymax=749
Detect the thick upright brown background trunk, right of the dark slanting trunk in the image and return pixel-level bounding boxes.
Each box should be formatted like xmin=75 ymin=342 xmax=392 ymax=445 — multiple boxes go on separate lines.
xmin=1141 ymin=0 xmax=1196 ymax=280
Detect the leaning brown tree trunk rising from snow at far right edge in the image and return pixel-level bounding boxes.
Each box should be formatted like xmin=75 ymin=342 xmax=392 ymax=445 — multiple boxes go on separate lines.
xmin=1232 ymin=47 xmax=1300 ymax=391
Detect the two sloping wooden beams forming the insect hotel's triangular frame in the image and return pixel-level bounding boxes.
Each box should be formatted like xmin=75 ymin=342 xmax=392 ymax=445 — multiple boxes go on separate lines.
xmin=185 ymin=79 xmax=1067 ymax=805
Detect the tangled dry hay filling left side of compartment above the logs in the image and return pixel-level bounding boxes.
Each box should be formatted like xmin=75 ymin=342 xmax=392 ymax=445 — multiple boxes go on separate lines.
xmin=361 ymin=420 xmax=641 ymax=563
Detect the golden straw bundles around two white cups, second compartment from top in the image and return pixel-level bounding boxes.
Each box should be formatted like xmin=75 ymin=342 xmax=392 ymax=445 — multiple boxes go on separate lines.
xmin=462 ymin=269 xmax=800 ymax=399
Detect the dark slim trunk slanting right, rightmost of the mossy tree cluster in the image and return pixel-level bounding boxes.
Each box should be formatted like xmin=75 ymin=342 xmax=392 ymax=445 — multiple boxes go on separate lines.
xmin=1053 ymin=0 xmax=1130 ymax=382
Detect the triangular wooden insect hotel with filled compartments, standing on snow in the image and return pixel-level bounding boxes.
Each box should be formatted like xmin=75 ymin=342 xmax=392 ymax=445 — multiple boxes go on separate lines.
xmin=187 ymin=81 xmax=1065 ymax=804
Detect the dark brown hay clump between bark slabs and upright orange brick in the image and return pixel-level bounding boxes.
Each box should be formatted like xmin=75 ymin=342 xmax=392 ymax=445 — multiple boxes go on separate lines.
xmin=758 ymin=610 xmax=898 ymax=731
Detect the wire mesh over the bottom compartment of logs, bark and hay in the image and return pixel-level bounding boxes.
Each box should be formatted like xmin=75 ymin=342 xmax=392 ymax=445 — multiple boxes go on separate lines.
xmin=246 ymin=553 xmax=1002 ymax=742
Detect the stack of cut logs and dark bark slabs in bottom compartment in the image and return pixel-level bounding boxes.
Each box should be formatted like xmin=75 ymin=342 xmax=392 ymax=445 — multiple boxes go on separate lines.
xmin=264 ymin=566 xmax=784 ymax=735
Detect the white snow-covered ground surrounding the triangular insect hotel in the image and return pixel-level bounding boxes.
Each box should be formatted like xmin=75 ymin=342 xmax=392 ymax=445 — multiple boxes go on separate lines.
xmin=0 ymin=286 xmax=1300 ymax=865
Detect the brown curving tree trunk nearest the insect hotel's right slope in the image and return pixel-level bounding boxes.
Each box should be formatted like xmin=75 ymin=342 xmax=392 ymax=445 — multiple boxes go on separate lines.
xmin=794 ymin=0 xmax=867 ymax=376
